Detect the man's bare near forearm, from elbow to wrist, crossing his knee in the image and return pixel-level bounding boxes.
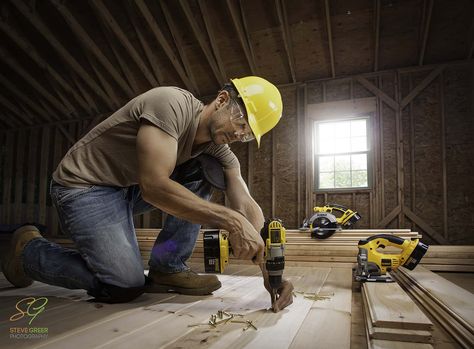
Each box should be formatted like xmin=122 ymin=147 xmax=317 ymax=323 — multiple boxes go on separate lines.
xmin=141 ymin=179 xmax=239 ymax=230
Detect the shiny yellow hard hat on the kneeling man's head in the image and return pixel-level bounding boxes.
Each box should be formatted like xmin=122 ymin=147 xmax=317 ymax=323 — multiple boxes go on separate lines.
xmin=231 ymin=76 xmax=283 ymax=147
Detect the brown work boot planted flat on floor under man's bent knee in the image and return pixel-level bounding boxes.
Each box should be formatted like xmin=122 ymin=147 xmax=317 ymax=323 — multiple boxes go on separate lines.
xmin=145 ymin=269 xmax=222 ymax=296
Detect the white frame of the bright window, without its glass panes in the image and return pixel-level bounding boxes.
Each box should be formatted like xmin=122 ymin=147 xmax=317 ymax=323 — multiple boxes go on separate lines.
xmin=312 ymin=112 xmax=374 ymax=190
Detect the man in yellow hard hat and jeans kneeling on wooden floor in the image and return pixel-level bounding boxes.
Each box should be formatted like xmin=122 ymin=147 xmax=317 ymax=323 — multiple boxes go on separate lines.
xmin=2 ymin=76 xmax=293 ymax=311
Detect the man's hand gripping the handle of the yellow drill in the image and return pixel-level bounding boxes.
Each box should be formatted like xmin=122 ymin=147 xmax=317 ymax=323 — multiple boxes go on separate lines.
xmin=228 ymin=213 xmax=265 ymax=264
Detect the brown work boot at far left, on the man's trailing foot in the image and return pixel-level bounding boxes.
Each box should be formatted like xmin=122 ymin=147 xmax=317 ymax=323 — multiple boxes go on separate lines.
xmin=2 ymin=225 xmax=42 ymax=287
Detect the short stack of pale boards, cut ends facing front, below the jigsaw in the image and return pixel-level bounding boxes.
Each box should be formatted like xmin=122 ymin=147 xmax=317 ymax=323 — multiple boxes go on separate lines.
xmin=362 ymin=282 xmax=434 ymax=348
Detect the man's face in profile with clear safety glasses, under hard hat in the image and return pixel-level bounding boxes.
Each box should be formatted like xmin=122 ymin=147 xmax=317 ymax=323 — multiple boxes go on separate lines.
xmin=209 ymin=95 xmax=254 ymax=144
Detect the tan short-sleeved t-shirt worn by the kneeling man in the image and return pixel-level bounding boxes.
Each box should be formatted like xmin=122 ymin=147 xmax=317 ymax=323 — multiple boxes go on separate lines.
xmin=53 ymin=87 xmax=240 ymax=187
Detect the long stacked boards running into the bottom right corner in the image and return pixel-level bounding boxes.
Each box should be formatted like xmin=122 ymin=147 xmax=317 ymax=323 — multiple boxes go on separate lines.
xmin=392 ymin=266 xmax=474 ymax=348
